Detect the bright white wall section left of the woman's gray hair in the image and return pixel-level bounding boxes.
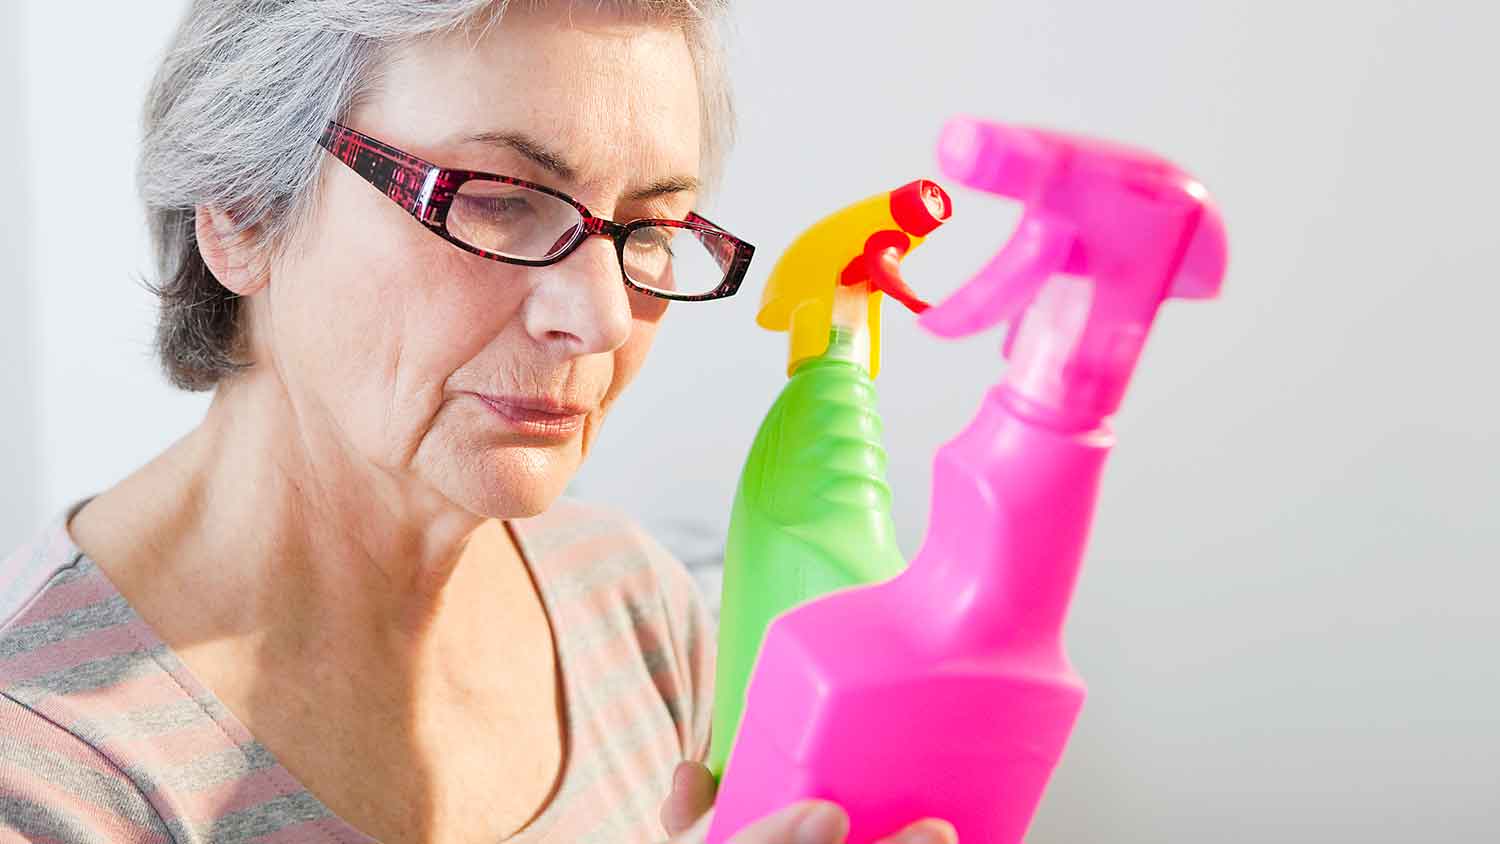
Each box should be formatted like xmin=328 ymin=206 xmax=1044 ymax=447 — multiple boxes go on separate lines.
xmin=21 ymin=0 xmax=207 ymax=527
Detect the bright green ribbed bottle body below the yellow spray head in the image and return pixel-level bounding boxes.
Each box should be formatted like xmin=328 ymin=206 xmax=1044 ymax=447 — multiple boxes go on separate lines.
xmin=708 ymin=330 xmax=906 ymax=777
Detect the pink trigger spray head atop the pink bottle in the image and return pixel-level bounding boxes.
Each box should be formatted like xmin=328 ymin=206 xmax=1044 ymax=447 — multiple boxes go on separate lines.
xmin=920 ymin=117 xmax=1227 ymax=420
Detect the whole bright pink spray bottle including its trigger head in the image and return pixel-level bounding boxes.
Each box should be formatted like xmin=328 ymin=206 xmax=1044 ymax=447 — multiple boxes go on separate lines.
xmin=708 ymin=118 xmax=1226 ymax=844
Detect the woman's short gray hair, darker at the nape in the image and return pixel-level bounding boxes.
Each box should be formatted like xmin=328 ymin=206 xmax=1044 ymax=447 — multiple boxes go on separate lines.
xmin=138 ymin=0 xmax=734 ymax=390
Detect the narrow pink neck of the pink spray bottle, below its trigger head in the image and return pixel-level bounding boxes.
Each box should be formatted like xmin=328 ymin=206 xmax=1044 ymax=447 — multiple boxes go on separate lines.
xmin=900 ymin=385 xmax=1113 ymax=657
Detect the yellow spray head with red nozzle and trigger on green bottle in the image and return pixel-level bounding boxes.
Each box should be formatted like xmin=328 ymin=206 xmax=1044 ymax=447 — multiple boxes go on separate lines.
xmin=756 ymin=178 xmax=953 ymax=378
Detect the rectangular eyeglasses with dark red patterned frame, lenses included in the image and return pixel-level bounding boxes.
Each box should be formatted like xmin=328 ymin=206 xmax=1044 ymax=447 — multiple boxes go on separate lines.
xmin=318 ymin=120 xmax=755 ymax=301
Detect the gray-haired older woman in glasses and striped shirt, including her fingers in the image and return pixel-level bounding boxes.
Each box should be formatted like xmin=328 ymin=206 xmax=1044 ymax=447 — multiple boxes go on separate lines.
xmin=0 ymin=0 xmax=953 ymax=844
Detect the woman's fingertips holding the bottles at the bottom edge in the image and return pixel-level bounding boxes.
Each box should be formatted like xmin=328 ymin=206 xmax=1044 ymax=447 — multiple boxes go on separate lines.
xmin=662 ymin=762 xmax=959 ymax=844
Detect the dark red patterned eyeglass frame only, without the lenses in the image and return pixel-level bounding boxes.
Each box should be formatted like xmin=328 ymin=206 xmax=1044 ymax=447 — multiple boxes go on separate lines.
xmin=318 ymin=120 xmax=755 ymax=301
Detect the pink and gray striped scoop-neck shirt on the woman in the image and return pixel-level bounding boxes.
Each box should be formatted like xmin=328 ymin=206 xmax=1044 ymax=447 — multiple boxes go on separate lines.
xmin=0 ymin=499 xmax=713 ymax=844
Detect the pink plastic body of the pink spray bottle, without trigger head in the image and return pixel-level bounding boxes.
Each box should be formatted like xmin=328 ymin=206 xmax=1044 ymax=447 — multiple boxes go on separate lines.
xmin=710 ymin=387 xmax=1110 ymax=844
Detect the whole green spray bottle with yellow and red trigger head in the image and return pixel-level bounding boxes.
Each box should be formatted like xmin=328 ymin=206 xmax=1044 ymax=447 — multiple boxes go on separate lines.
xmin=708 ymin=180 xmax=953 ymax=777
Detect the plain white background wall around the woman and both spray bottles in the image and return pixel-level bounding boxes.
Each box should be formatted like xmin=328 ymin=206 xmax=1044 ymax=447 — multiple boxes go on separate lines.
xmin=0 ymin=0 xmax=1500 ymax=844
